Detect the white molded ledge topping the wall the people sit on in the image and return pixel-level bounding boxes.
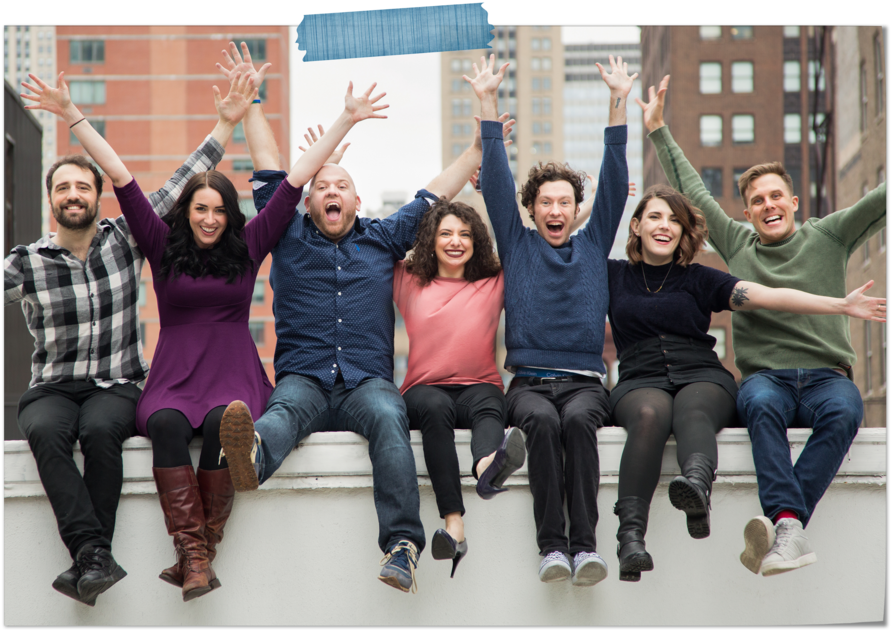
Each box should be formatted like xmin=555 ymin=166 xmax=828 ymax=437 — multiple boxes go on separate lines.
xmin=3 ymin=427 xmax=888 ymax=499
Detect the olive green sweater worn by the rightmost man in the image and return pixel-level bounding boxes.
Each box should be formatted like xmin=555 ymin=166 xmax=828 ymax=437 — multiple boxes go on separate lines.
xmin=649 ymin=126 xmax=888 ymax=378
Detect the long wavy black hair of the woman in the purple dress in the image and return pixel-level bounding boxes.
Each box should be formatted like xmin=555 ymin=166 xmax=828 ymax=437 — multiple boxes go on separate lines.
xmin=161 ymin=171 xmax=255 ymax=284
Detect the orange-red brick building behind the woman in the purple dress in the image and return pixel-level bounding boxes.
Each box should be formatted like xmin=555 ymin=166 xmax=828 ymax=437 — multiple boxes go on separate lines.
xmin=50 ymin=25 xmax=290 ymax=380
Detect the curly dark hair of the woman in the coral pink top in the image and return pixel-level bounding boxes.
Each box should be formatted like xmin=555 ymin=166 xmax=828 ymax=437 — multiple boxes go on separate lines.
xmin=405 ymin=197 xmax=501 ymax=287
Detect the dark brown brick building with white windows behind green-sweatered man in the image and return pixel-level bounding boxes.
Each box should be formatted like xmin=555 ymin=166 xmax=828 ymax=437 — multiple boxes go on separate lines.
xmin=641 ymin=25 xmax=836 ymax=379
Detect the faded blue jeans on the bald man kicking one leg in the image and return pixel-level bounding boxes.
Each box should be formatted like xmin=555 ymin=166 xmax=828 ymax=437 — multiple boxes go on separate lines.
xmin=254 ymin=374 xmax=425 ymax=553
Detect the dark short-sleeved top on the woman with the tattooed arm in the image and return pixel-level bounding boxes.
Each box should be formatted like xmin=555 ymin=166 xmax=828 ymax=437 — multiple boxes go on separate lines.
xmin=597 ymin=260 xmax=739 ymax=360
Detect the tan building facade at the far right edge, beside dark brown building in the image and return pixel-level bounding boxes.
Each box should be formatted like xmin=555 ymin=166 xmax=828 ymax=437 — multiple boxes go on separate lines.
xmin=832 ymin=26 xmax=888 ymax=427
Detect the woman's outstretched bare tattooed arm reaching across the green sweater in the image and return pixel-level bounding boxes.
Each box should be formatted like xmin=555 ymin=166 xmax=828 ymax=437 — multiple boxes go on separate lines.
xmin=730 ymin=280 xmax=888 ymax=322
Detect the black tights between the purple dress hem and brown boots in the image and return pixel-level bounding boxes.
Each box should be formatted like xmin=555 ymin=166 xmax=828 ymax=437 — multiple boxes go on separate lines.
xmin=146 ymin=406 xmax=229 ymax=470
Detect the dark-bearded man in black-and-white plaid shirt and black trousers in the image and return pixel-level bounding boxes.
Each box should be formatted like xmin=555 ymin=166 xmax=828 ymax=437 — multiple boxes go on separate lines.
xmin=3 ymin=71 xmax=247 ymax=606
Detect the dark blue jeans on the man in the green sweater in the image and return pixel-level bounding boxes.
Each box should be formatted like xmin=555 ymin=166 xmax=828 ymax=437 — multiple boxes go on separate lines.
xmin=736 ymin=368 xmax=863 ymax=527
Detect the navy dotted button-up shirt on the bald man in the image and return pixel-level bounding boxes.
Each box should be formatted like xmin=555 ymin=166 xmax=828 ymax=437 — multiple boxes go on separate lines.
xmin=251 ymin=171 xmax=436 ymax=391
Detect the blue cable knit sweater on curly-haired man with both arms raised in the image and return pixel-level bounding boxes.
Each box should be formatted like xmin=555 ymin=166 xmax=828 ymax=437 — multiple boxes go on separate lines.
xmin=480 ymin=120 xmax=628 ymax=374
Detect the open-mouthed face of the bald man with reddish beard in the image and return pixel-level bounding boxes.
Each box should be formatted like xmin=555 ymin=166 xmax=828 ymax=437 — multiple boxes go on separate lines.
xmin=303 ymin=164 xmax=362 ymax=242
